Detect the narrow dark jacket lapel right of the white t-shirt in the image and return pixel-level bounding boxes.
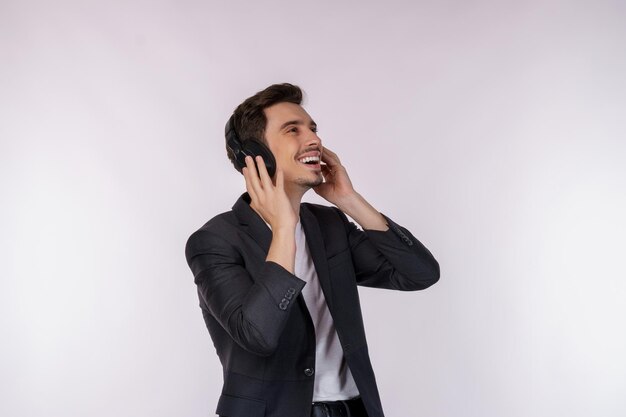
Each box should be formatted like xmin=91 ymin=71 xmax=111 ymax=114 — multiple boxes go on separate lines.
xmin=300 ymin=204 xmax=333 ymax=312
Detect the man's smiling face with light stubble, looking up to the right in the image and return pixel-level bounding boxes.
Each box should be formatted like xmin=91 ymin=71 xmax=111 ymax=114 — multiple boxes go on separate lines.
xmin=264 ymin=103 xmax=323 ymax=189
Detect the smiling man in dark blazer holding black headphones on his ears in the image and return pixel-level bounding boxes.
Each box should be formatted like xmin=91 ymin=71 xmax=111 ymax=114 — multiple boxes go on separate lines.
xmin=186 ymin=84 xmax=439 ymax=417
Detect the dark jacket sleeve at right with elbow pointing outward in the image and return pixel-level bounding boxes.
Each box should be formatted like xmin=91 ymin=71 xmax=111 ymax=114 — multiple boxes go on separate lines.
xmin=338 ymin=210 xmax=439 ymax=291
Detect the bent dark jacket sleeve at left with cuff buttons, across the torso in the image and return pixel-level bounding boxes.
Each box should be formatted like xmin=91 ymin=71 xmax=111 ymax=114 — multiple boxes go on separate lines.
xmin=185 ymin=229 xmax=305 ymax=356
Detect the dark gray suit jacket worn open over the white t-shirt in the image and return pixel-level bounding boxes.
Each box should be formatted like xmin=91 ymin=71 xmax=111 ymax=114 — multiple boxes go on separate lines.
xmin=185 ymin=194 xmax=439 ymax=417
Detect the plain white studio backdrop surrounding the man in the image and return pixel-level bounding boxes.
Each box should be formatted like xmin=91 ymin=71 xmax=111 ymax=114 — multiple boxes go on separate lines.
xmin=0 ymin=0 xmax=626 ymax=417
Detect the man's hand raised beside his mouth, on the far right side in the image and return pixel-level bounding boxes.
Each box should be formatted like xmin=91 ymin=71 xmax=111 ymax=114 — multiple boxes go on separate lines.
xmin=313 ymin=147 xmax=356 ymax=207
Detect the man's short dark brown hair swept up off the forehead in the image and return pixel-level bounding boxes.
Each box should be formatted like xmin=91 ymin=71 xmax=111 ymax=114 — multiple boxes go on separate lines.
xmin=226 ymin=83 xmax=302 ymax=166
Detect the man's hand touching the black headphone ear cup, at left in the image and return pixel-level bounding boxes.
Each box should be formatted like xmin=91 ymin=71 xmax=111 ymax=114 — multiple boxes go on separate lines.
xmin=242 ymin=156 xmax=298 ymax=231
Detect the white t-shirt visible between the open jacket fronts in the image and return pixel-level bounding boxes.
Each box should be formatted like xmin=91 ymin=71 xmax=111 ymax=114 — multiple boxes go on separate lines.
xmin=294 ymin=222 xmax=359 ymax=401
